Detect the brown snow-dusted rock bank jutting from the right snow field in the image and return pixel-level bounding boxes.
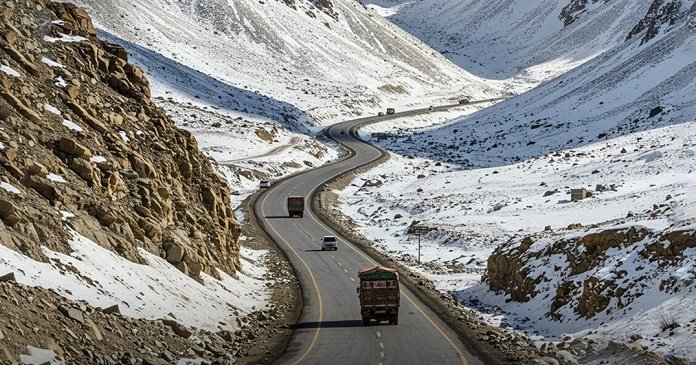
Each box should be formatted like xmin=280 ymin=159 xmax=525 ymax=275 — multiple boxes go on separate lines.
xmin=483 ymin=227 xmax=696 ymax=320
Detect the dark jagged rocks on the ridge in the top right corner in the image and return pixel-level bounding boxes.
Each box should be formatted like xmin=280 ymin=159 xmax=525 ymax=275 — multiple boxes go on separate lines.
xmin=626 ymin=0 xmax=696 ymax=44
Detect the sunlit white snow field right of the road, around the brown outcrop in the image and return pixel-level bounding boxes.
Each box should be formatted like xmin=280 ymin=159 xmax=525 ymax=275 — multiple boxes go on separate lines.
xmin=337 ymin=115 xmax=696 ymax=357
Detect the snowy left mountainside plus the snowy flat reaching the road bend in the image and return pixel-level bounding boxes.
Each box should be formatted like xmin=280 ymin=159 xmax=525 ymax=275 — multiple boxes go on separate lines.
xmin=62 ymin=0 xmax=500 ymax=199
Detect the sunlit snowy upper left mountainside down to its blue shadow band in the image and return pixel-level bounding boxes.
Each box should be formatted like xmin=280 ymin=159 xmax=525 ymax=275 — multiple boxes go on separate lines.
xmin=68 ymin=0 xmax=494 ymax=126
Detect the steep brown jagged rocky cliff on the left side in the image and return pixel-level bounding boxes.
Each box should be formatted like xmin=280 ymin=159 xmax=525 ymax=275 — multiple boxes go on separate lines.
xmin=0 ymin=0 xmax=240 ymax=277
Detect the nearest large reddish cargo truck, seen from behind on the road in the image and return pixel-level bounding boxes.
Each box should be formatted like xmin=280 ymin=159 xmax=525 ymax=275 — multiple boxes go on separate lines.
xmin=358 ymin=266 xmax=400 ymax=326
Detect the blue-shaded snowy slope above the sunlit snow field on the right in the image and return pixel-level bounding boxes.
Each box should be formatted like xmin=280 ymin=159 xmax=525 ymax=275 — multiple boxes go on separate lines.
xmin=376 ymin=3 xmax=696 ymax=167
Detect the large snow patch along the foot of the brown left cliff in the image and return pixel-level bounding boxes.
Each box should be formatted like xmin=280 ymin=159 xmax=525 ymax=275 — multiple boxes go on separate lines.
xmin=0 ymin=230 xmax=268 ymax=331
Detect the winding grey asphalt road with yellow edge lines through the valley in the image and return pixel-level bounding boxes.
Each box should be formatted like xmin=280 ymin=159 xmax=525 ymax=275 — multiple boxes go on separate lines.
xmin=254 ymin=100 xmax=502 ymax=365
